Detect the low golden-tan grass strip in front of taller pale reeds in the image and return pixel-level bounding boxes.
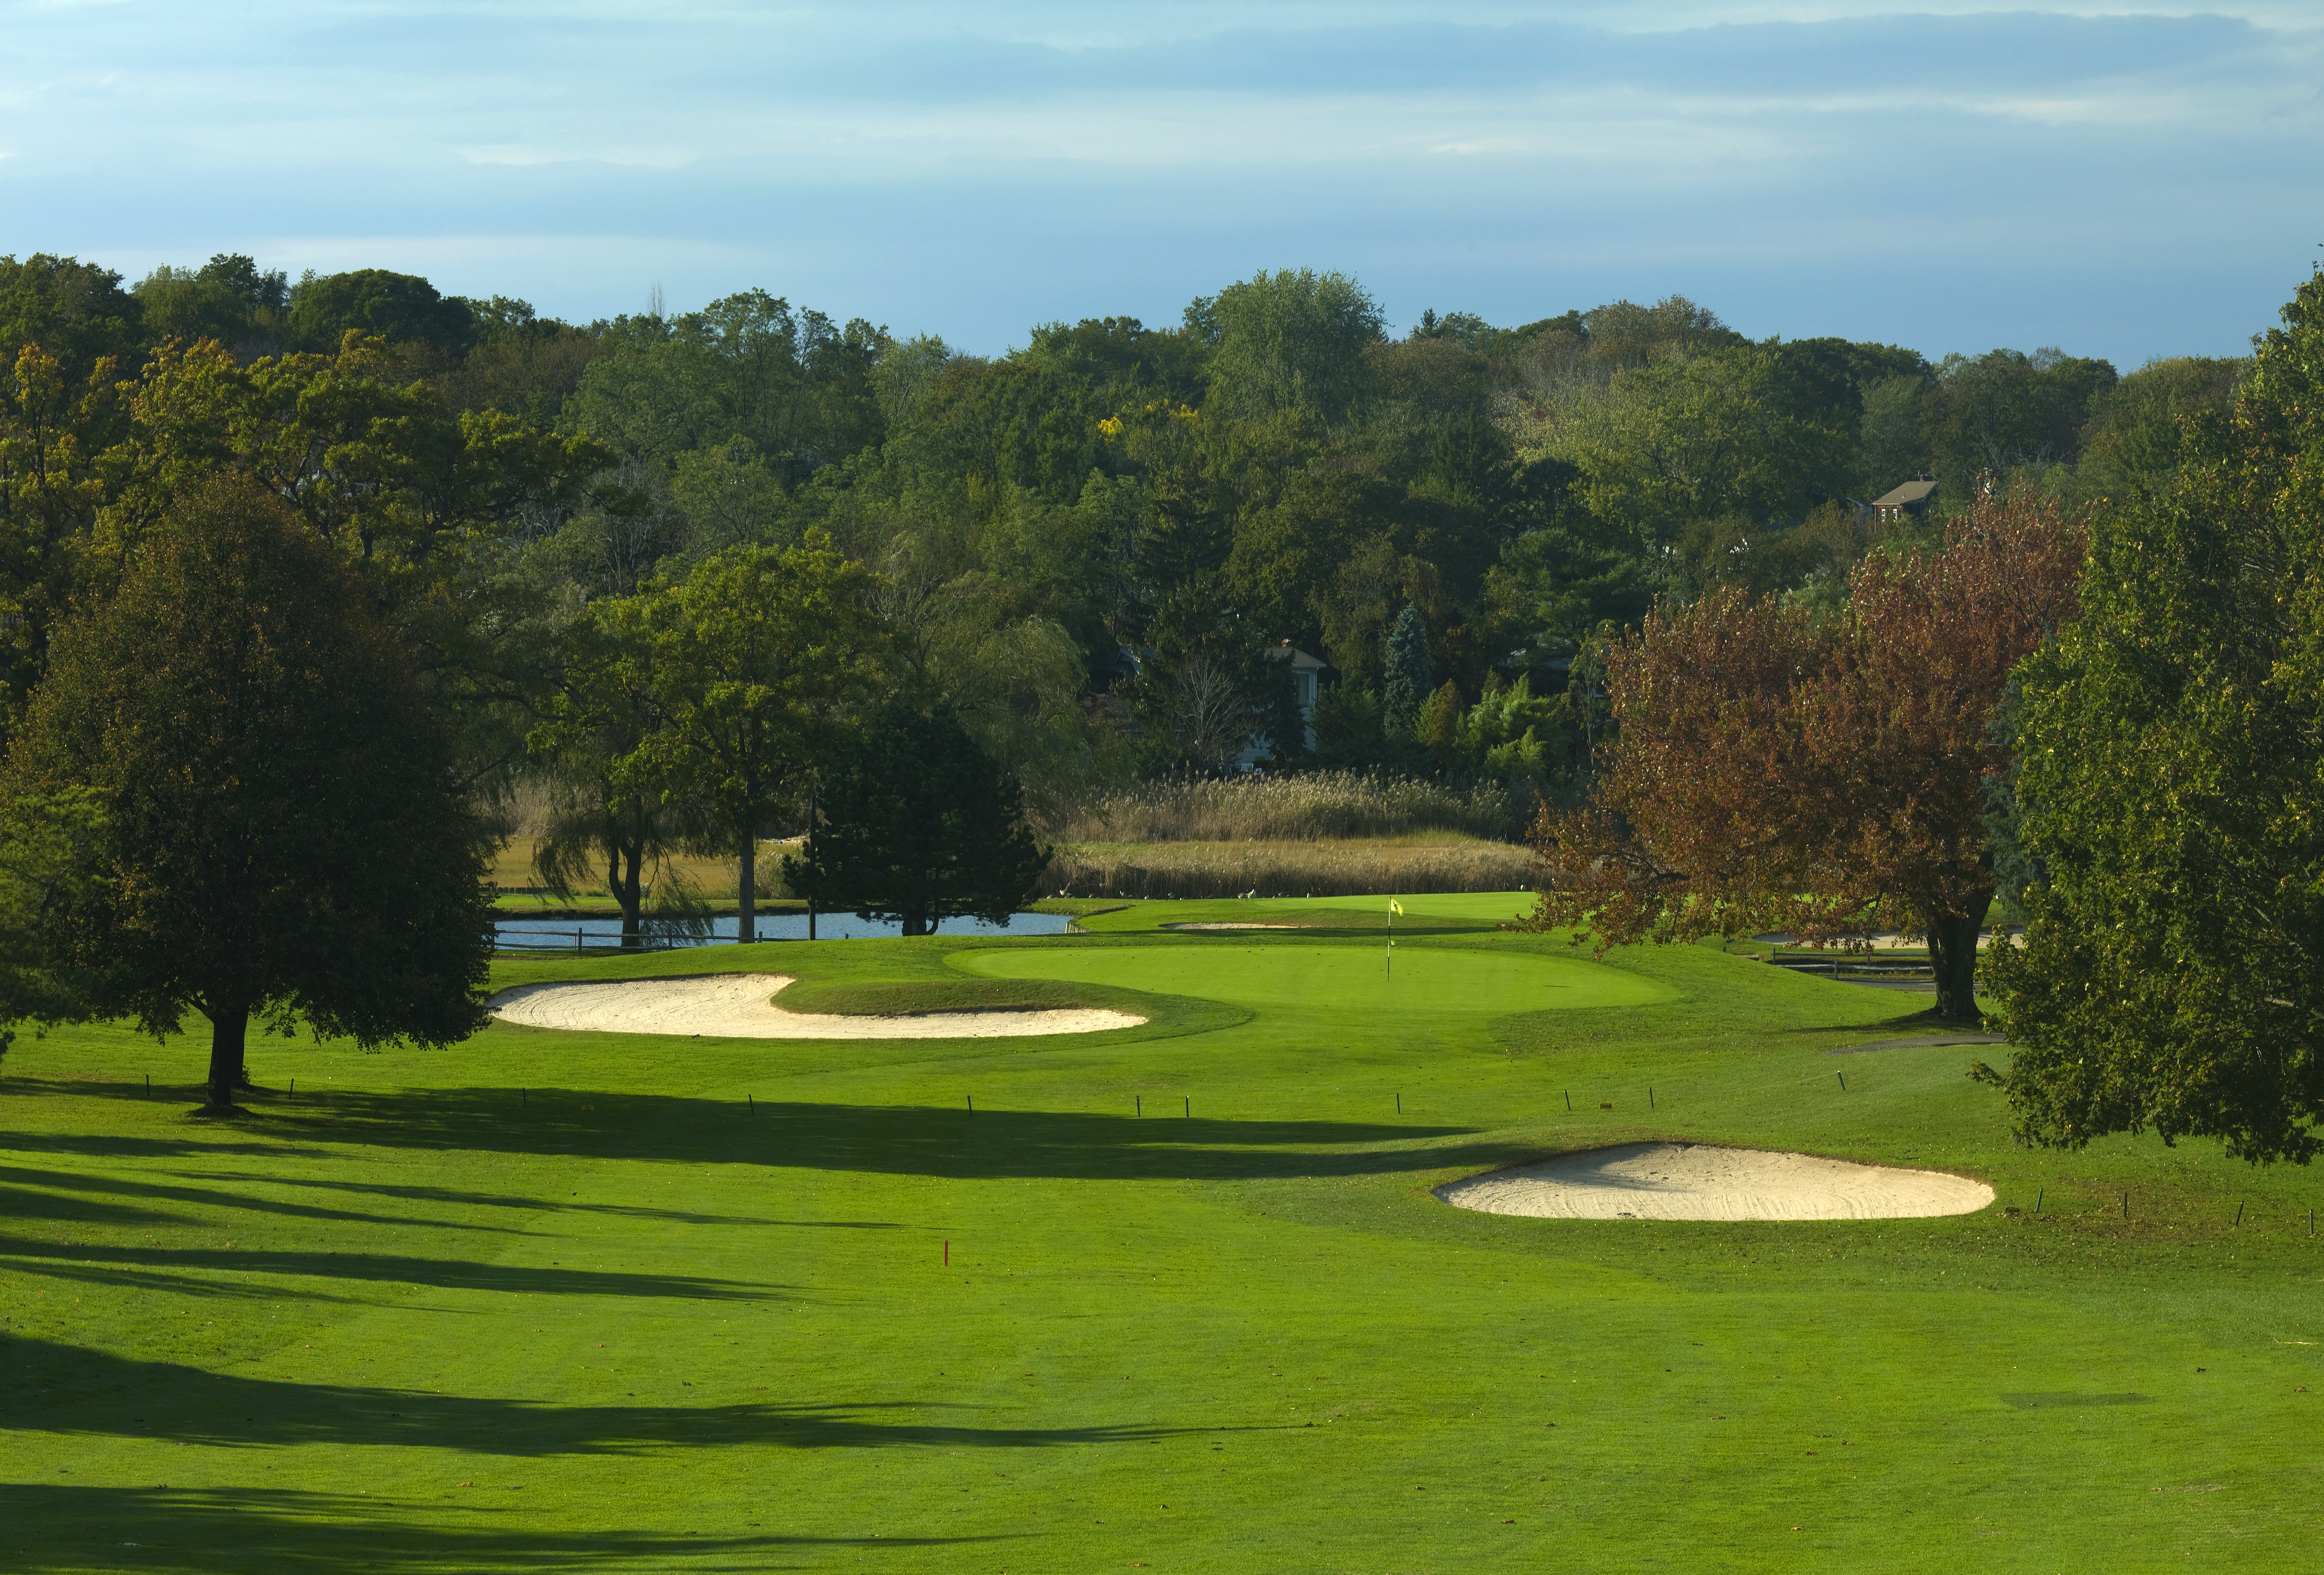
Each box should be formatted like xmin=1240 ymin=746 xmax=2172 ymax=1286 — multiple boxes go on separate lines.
xmin=1046 ymin=839 xmax=1532 ymax=897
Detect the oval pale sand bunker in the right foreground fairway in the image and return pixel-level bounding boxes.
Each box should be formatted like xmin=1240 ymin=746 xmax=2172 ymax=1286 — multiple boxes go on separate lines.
xmin=1436 ymin=1143 xmax=1994 ymax=1220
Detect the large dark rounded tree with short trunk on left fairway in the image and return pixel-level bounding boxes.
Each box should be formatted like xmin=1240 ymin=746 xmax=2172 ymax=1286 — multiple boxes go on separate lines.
xmin=0 ymin=471 xmax=493 ymax=1106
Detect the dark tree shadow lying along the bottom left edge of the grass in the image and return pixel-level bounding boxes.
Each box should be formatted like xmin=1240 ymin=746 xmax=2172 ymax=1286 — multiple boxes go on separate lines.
xmin=0 ymin=1484 xmax=1002 ymax=1575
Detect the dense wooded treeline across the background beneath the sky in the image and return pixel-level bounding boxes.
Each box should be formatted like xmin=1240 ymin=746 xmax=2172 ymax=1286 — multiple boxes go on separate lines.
xmin=0 ymin=256 xmax=2245 ymax=822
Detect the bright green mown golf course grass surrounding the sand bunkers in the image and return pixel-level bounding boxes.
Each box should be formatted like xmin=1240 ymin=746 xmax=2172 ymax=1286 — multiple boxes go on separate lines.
xmin=0 ymin=899 xmax=2324 ymax=1575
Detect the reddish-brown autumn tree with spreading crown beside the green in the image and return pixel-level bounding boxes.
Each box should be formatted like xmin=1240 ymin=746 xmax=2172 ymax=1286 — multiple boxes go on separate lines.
xmin=1529 ymin=495 xmax=2082 ymax=1020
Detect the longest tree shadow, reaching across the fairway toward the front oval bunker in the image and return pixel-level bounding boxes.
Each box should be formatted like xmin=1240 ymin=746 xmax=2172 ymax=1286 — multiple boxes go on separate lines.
xmin=9 ymin=1087 xmax=1513 ymax=1180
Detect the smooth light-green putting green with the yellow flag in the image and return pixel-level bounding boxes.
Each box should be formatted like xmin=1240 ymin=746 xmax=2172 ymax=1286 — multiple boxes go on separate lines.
xmin=953 ymin=941 xmax=1676 ymax=1018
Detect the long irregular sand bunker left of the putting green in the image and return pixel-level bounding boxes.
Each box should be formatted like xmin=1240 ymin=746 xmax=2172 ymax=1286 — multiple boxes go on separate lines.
xmin=486 ymin=973 xmax=1146 ymax=1038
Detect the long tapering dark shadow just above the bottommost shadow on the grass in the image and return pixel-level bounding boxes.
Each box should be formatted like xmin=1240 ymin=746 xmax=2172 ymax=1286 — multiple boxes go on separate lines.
xmin=0 ymin=1340 xmax=1220 ymax=1459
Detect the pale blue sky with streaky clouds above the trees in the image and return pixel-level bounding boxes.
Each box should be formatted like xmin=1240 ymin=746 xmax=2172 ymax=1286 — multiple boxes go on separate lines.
xmin=0 ymin=0 xmax=2324 ymax=369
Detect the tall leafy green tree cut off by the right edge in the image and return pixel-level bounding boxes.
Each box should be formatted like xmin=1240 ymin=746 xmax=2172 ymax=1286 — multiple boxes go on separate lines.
xmin=1978 ymin=274 xmax=2324 ymax=1164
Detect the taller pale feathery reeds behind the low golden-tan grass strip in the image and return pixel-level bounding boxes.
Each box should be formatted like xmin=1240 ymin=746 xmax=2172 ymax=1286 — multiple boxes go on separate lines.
xmin=1050 ymin=771 xmax=1534 ymax=845
